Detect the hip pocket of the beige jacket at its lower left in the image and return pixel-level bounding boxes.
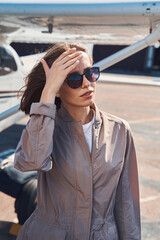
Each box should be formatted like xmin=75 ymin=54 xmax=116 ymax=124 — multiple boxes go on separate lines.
xmin=26 ymin=217 xmax=67 ymax=240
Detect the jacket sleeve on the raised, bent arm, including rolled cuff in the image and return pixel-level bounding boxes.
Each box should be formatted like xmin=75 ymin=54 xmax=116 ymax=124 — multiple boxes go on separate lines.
xmin=14 ymin=102 xmax=56 ymax=172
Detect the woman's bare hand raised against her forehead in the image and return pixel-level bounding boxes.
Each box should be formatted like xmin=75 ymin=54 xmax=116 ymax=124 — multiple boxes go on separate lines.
xmin=41 ymin=48 xmax=82 ymax=95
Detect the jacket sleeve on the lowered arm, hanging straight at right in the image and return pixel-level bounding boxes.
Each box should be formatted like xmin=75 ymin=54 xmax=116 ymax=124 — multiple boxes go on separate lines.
xmin=115 ymin=124 xmax=141 ymax=240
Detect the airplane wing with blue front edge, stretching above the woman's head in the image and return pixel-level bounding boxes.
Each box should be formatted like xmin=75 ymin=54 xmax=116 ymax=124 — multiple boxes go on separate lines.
xmin=0 ymin=0 xmax=160 ymax=45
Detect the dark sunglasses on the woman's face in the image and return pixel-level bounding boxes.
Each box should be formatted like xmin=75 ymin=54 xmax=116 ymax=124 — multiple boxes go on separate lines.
xmin=65 ymin=67 xmax=100 ymax=89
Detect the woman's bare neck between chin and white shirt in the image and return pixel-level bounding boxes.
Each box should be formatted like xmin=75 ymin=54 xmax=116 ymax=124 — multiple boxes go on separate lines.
xmin=63 ymin=104 xmax=93 ymax=125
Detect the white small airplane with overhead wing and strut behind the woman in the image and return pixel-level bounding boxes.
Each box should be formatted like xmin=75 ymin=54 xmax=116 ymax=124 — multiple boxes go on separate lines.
xmin=0 ymin=0 xmax=160 ymax=131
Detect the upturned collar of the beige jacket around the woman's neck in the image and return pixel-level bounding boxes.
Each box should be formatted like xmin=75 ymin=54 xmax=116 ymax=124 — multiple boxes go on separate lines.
xmin=57 ymin=103 xmax=102 ymax=125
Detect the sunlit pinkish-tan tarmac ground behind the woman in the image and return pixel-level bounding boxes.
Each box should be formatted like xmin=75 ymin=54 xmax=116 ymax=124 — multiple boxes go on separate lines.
xmin=0 ymin=79 xmax=160 ymax=240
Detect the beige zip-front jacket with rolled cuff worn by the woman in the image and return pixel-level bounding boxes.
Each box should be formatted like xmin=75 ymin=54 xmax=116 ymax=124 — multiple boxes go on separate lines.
xmin=15 ymin=103 xmax=141 ymax=240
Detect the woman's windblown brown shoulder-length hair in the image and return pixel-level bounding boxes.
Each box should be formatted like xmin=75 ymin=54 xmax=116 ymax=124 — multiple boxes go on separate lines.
xmin=18 ymin=43 xmax=92 ymax=114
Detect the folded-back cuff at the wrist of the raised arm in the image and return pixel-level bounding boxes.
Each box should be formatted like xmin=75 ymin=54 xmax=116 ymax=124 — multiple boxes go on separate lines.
xmin=29 ymin=102 xmax=56 ymax=119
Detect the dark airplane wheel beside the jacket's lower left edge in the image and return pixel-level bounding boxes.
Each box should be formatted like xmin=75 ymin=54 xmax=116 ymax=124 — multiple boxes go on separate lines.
xmin=15 ymin=179 xmax=37 ymax=225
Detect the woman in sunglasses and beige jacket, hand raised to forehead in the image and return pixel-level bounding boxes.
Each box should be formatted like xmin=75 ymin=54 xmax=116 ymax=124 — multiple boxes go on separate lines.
xmin=15 ymin=43 xmax=141 ymax=240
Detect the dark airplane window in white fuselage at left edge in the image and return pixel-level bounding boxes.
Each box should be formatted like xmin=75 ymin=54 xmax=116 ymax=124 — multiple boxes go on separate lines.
xmin=0 ymin=47 xmax=17 ymax=76
